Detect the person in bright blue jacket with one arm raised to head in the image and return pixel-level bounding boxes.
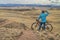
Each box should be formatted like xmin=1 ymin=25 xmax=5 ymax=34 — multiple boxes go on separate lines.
xmin=37 ymin=10 xmax=49 ymax=31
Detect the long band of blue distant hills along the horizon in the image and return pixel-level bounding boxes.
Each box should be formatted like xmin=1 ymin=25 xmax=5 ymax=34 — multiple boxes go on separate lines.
xmin=0 ymin=4 xmax=60 ymax=8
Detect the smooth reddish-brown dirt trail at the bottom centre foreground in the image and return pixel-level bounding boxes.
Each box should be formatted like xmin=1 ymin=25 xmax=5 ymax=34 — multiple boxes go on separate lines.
xmin=18 ymin=30 xmax=39 ymax=40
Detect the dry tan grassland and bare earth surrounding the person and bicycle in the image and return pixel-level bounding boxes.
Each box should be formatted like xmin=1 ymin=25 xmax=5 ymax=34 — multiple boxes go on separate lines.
xmin=0 ymin=10 xmax=60 ymax=40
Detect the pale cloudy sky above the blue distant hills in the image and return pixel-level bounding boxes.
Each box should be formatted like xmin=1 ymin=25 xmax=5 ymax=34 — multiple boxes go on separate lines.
xmin=0 ymin=0 xmax=60 ymax=4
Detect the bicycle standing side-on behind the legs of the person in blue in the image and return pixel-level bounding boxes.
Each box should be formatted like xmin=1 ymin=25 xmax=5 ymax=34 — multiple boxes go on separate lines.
xmin=31 ymin=21 xmax=53 ymax=32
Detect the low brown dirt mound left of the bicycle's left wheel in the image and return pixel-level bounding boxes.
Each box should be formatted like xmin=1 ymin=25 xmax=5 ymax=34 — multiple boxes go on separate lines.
xmin=3 ymin=22 xmax=27 ymax=30
